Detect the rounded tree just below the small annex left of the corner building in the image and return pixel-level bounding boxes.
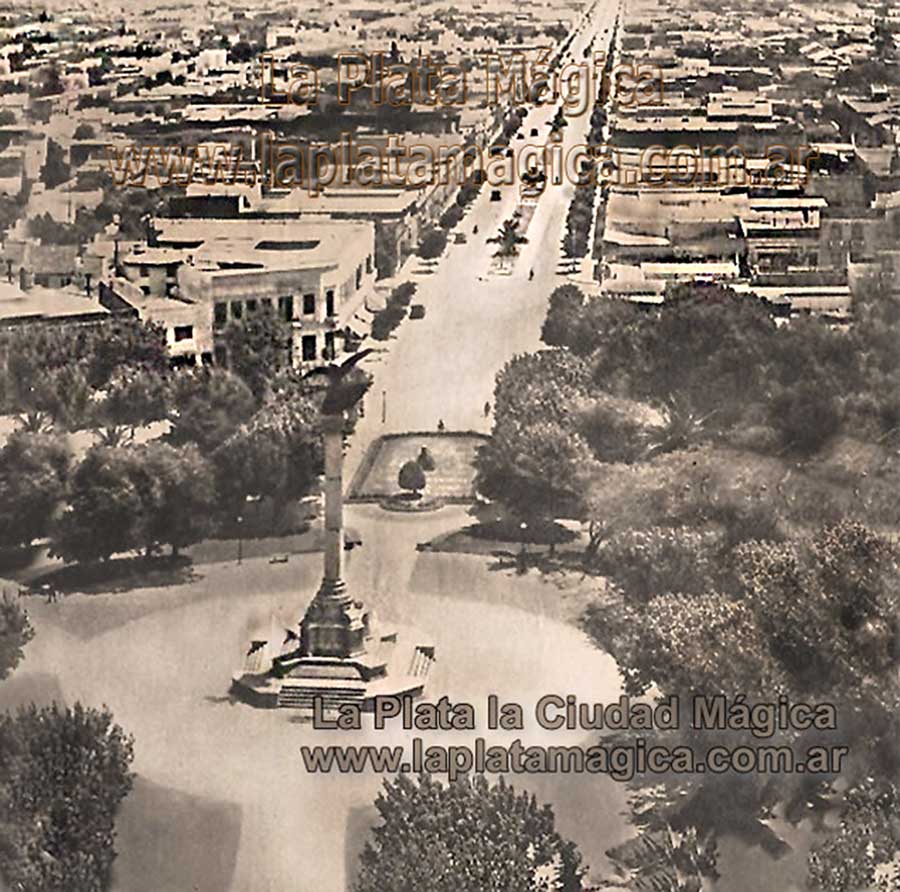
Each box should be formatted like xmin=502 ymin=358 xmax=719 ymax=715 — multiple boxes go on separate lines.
xmin=169 ymin=368 xmax=256 ymax=453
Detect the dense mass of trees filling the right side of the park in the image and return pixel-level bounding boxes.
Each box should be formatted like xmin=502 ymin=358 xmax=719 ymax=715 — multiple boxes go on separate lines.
xmin=477 ymin=278 xmax=900 ymax=880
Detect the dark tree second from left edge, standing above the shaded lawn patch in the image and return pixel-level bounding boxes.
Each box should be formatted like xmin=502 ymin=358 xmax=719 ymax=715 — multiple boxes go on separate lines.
xmin=51 ymin=446 xmax=144 ymax=562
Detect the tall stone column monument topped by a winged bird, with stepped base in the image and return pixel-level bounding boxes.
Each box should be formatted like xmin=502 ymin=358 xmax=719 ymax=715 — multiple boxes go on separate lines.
xmin=233 ymin=351 xmax=434 ymax=712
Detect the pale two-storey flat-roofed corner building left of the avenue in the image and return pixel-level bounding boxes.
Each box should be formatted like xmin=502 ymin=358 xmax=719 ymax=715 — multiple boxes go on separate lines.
xmin=114 ymin=218 xmax=375 ymax=367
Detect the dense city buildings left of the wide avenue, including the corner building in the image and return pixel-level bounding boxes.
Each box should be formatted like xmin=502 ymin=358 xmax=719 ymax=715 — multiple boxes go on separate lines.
xmin=0 ymin=0 xmax=580 ymax=366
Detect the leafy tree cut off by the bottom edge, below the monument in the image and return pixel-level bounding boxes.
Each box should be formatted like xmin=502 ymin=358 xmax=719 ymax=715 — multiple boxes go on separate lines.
xmin=354 ymin=774 xmax=583 ymax=892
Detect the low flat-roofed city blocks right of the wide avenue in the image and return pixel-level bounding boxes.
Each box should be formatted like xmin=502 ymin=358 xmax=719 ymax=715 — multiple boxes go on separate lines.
xmin=595 ymin=0 xmax=900 ymax=320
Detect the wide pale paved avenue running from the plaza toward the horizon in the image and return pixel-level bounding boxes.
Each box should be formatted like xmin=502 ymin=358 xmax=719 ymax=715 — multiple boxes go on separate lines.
xmin=345 ymin=0 xmax=617 ymax=481
